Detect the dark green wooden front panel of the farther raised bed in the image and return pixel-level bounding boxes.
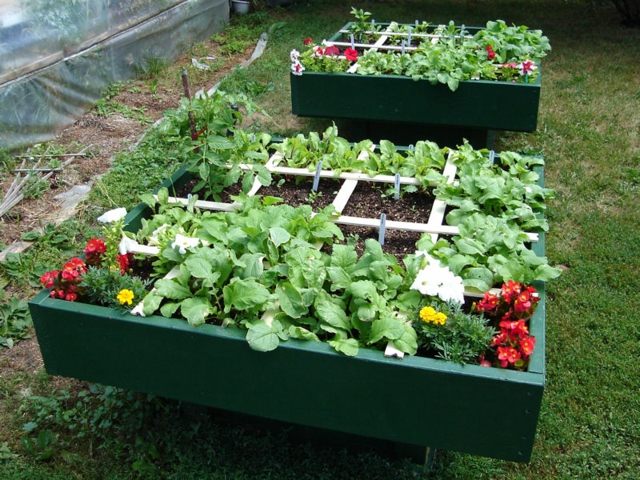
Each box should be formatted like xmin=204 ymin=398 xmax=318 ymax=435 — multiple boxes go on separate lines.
xmin=291 ymin=72 xmax=542 ymax=132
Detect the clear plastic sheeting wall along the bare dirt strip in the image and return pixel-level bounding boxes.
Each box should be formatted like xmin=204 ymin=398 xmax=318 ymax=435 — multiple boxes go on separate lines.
xmin=0 ymin=0 xmax=229 ymax=149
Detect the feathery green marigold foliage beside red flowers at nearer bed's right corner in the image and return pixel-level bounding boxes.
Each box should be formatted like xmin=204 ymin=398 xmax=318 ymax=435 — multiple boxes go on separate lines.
xmin=413 ymin=303 xmax=496 ymax=364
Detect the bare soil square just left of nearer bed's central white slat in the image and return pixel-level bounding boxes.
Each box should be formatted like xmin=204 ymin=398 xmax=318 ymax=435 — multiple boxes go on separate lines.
xmin=258 ymin=175 xmax=341 ymax=209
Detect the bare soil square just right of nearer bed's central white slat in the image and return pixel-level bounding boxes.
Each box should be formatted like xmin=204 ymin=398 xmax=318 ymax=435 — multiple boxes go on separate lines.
xmin=342 ymin=182 xmax=434 ymax=223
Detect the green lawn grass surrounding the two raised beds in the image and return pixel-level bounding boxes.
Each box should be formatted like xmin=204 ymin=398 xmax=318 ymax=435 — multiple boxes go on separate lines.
xmin=0 ymin=0 xmax=640 ymax=480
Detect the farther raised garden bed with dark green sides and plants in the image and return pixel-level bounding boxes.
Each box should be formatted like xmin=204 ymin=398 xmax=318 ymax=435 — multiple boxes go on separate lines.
xmin=291 ymin=17 xmax=546 ymax=134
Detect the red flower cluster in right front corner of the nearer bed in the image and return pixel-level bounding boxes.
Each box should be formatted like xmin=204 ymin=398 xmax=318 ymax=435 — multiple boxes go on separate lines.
xmin=475 ymin=280 xmax=540 ymax=370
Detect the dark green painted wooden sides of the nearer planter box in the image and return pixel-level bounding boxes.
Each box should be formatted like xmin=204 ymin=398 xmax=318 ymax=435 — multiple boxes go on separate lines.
xmin=29 ymin=167 xmax=545 ymax=461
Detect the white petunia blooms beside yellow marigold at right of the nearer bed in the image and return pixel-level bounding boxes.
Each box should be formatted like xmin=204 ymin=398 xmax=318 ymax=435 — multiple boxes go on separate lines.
xmin=411 ymin=252 xmax=464 ymax=304
